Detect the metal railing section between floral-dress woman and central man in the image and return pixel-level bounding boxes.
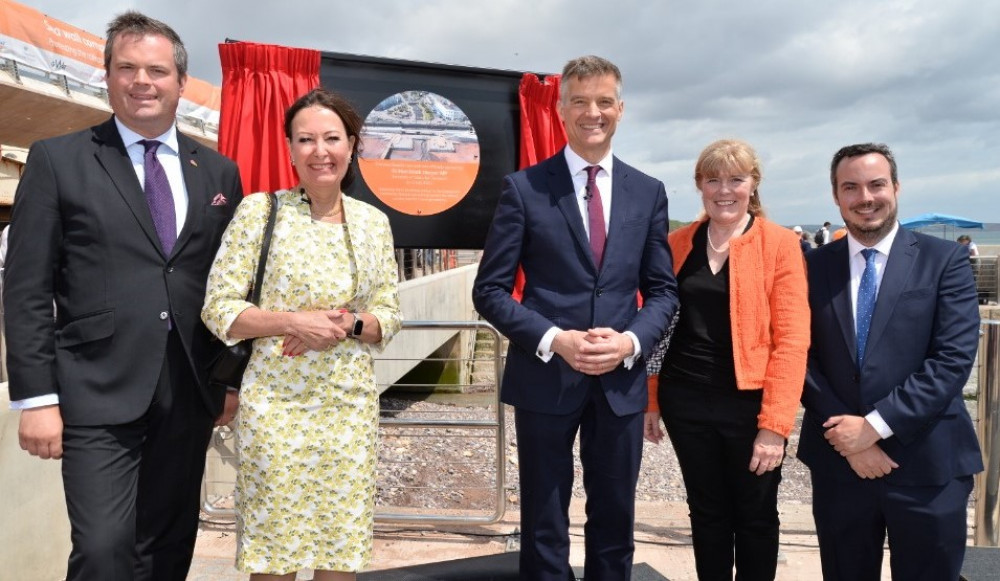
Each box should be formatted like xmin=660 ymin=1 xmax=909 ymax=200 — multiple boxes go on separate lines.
xmin=202 ymin=321 xmax=506 ymax=525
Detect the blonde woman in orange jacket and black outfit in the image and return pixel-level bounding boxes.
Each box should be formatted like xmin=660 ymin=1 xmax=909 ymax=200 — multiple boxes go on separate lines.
xmin=645 ymin=140 xmax=809 ymax=581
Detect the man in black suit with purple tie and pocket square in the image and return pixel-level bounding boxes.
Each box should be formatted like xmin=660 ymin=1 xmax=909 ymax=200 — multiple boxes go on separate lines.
xmin=4 ymin=12 xmax=242 ymax=581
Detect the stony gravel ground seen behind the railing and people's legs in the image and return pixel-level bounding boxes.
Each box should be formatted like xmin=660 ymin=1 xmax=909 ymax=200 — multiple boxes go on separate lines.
xmin=378 ymin=396 xmax=811 ymax=510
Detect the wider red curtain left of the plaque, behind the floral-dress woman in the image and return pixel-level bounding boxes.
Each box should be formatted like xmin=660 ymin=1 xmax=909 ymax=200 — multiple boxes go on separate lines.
xmin=219 ymin=42 xmax=320 ymax=194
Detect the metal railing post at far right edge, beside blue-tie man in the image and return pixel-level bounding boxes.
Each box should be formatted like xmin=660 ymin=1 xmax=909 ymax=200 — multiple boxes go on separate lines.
xmin=973 ymin=320 xmax=1000 ymax=547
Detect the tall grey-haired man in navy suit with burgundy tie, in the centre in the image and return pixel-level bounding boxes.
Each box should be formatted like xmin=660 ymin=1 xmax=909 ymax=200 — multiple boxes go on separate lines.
xmin=472 ymin=56 xmax=677 ymax=581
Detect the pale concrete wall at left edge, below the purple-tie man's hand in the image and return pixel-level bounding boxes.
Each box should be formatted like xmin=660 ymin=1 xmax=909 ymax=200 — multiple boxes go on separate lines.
xmin=0 ymin=383 xmax=70 ymax=581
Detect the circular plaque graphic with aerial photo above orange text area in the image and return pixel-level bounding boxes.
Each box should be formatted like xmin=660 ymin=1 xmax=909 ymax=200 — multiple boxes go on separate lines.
xmin=358 ymin=91 xmax=479 ymax=216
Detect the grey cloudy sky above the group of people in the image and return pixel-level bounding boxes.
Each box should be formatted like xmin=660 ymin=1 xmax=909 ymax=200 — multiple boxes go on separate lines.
xmin=21 ymin=0 xmax=1000 ymax=225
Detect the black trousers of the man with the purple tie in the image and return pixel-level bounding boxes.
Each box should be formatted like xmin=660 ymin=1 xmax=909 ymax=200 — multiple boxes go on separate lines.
xmin=62 ymin=331 xmax=214 ymax=581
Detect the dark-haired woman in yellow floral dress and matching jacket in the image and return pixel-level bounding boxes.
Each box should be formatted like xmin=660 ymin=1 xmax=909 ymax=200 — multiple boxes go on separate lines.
xmin=202 ymin=89 xmax=401 ymax=581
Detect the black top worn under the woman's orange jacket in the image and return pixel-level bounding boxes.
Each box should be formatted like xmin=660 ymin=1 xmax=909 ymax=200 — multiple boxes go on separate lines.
xmin=660 ymin=217 xmax=753 ymax=391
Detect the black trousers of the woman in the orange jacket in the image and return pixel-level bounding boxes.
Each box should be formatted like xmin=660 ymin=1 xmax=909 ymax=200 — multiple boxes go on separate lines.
xmin=659 ymin=378 xmax=781 ymax=581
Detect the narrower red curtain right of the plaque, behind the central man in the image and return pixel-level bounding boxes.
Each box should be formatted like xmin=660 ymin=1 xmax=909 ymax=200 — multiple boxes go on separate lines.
xmin=512 ymin=73 xmax=566 ymax=301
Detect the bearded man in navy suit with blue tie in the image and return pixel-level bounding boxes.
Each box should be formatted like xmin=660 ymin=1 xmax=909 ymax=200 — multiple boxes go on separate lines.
xmin=798 ymin=143 xmax=983 ymax=581
